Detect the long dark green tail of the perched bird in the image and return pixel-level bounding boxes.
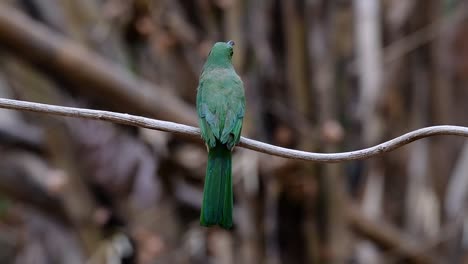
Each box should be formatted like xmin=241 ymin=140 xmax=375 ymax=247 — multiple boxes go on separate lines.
xmin=200 ymin=142 xmax=233 ymax=229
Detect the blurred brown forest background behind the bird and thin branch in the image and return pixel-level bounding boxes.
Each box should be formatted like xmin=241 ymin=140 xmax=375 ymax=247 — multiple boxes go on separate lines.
xmin=0 ymin=0 xmax=468 ymax=264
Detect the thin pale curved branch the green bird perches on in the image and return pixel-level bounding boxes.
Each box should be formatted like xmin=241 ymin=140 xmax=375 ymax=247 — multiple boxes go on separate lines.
xmin=0 ymin=98 xmax=468 ymax=163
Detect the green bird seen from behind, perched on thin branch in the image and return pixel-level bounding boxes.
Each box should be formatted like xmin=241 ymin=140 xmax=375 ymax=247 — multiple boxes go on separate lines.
xmin=197 ymin=40 xmax=245 ymax=229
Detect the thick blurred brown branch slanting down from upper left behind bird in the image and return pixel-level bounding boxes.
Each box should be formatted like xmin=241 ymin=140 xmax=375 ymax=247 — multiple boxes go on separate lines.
xmin=0 ymin=4 xmax=196 ymax=125
